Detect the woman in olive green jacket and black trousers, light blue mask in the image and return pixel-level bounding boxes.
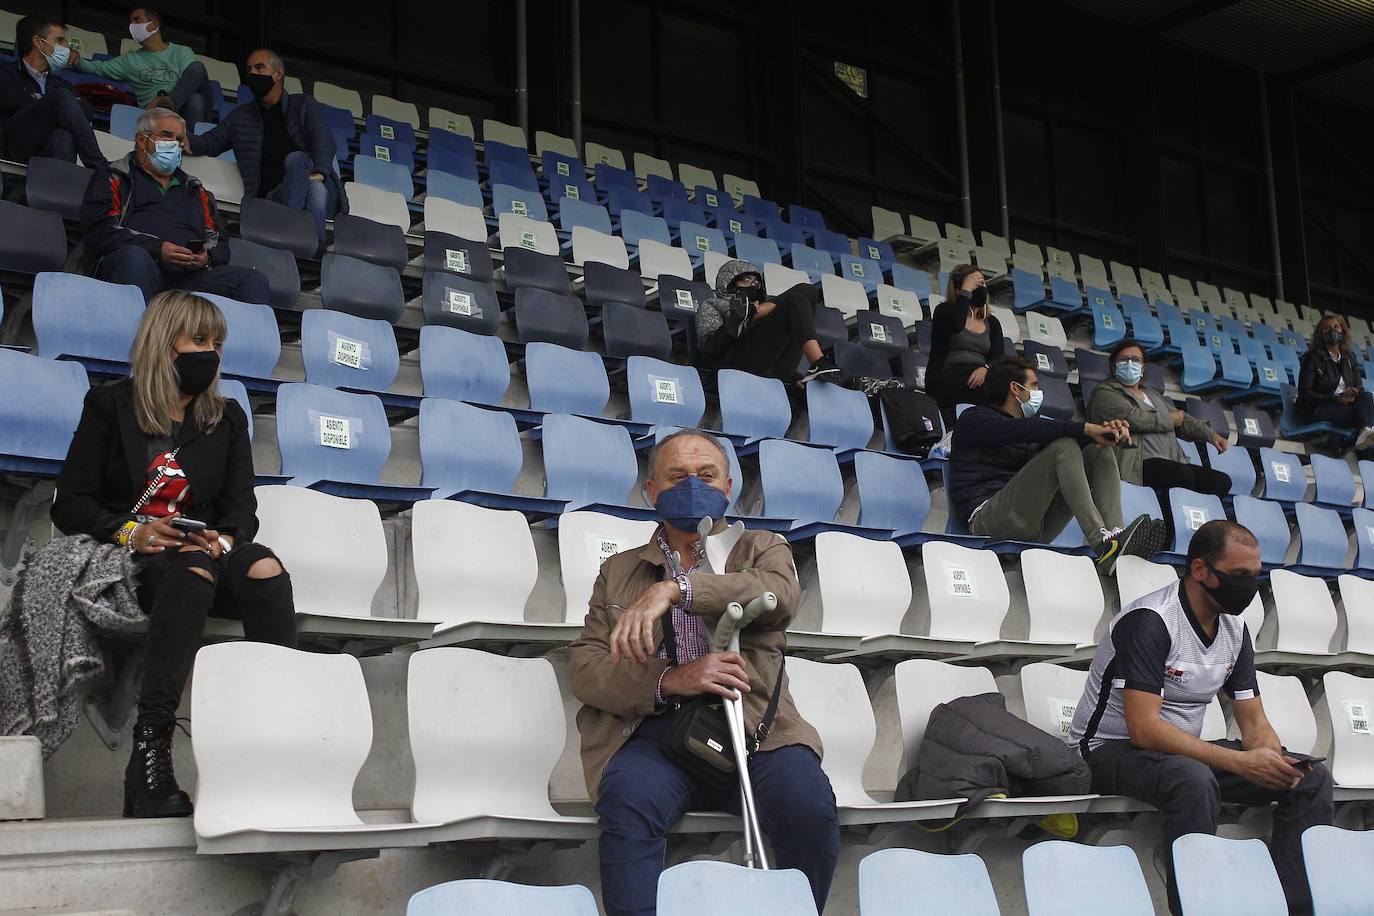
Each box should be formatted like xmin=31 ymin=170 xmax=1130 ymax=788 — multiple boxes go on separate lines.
xmin=1088 ymin=338 xmax=1231 ymax=525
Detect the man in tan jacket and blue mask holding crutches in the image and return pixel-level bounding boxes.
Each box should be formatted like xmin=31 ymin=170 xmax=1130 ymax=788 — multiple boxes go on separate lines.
xmin=569 ymin=430 xmax=840 ymax=916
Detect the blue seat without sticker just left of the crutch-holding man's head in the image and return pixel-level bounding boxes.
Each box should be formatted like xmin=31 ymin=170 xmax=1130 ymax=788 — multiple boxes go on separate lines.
xmin=543 ymin=413 xmax=655 ymax=526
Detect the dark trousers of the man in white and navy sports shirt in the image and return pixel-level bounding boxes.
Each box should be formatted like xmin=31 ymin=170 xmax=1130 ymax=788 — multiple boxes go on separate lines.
xmin=1088 ymin=740 xmax=1336 ymax=916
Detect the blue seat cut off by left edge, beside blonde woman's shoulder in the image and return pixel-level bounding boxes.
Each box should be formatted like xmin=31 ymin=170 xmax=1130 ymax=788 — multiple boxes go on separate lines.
xmin=0 ymin=347 xmax=91 ymax=477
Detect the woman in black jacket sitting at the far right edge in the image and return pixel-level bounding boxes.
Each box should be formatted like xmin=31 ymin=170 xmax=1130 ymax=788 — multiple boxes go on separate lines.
xmin=1294 ymin=314 xmax=1374 ymax=450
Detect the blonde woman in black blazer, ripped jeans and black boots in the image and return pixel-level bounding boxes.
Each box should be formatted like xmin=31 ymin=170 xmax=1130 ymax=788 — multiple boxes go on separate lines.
xmin=52 ymin=291 xmax=295 ymax=817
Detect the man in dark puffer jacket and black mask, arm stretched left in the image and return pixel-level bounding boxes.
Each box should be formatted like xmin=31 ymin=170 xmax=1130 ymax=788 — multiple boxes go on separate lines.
xmin=190 ymin=48 xmax=348 ymax=254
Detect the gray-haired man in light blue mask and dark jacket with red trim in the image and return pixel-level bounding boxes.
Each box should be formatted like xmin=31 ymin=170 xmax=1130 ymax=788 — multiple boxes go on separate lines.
xmin=81 ymin=108 xmax=268 ymax=304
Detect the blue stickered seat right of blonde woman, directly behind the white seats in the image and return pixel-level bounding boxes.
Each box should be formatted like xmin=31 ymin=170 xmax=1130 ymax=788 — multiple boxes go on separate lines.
xmin=276 ymin=382 xmax=431 ymax=504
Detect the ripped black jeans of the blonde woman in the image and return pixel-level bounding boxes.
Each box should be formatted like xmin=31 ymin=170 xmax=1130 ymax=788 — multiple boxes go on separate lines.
xmin=139 ymin=542 xmax=295 ymax=725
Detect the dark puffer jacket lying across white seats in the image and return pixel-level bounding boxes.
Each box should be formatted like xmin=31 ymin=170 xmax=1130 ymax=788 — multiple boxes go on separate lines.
xmin=894 ymin=694 xmax=1092 ymax=817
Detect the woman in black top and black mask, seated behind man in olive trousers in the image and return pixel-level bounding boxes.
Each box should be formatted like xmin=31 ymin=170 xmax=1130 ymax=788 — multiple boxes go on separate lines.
xmin=926 ymin=264 xmax=1003 ymax=428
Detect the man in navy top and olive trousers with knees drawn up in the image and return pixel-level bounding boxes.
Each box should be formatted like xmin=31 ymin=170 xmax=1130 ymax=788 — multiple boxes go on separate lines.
xmin=949 ymin=356 xmax=1168 ymax=575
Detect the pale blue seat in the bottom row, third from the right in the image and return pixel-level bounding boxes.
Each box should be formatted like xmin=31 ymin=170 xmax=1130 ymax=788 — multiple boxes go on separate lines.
xmin=1027 ymin=839 xmax=1154 ymax=916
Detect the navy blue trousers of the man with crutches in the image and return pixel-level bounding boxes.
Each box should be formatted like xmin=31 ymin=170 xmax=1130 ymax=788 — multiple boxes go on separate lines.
xmin=596 ymin=713 xmax=840 ymax=916
